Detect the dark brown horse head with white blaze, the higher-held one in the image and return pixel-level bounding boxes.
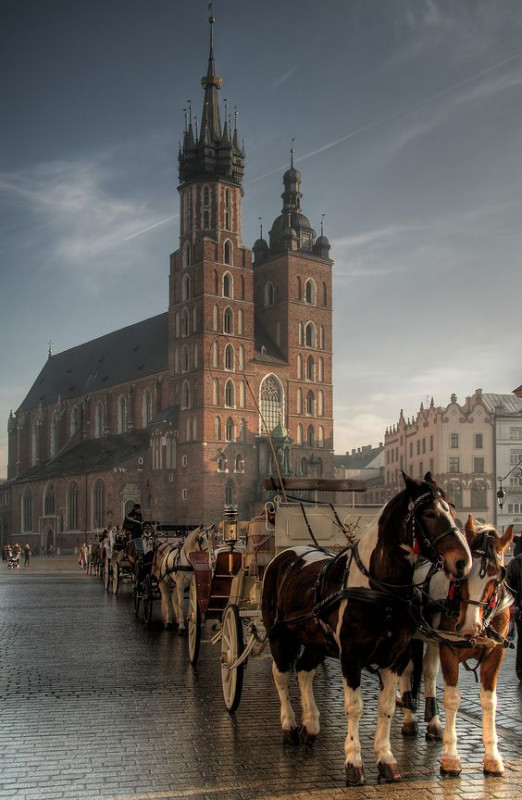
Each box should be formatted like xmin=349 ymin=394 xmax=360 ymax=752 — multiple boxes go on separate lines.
xmin=402 ymin=472 xmax=471 ymax=579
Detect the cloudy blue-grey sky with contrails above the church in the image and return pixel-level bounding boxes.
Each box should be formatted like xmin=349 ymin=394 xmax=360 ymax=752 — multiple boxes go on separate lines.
xmin=0 ymin=0 xmax=522 ymax=477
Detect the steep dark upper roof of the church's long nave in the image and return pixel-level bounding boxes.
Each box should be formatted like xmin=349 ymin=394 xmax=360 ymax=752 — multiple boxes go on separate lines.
xmin=18 ymin=312 xmax=168 ymax=411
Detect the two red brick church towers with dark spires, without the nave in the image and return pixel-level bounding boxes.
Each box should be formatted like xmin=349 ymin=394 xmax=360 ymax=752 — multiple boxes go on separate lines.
xmin=169 ymin=17 xmax=333 ymax=520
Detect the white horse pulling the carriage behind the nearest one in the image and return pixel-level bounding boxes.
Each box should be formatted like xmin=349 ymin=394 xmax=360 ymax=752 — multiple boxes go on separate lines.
xmin=152 ymin=525 xmax=215 ymax=636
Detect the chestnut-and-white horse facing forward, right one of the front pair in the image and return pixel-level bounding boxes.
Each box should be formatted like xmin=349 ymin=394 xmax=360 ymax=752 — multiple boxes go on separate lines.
xmin=401 ymin=515 xmax=513 ymax=776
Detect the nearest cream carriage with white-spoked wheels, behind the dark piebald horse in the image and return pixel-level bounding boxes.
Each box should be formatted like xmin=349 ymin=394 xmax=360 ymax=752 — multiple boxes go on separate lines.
xmin=188 ymin=478 xmax=378 ymax=712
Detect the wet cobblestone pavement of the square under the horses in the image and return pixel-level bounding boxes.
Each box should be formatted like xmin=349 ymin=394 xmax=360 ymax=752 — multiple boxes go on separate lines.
xmin=0 ymin=557 xmax=522 ymax=800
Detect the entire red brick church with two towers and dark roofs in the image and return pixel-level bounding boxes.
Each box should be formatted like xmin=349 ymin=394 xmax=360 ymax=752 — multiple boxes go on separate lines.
xmin=2 ymin=17 xmax=333 ymax=551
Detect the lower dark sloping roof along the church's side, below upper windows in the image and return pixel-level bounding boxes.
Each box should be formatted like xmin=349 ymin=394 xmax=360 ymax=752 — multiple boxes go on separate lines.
xmin=13 ymin=428 xmax=150 ymax=483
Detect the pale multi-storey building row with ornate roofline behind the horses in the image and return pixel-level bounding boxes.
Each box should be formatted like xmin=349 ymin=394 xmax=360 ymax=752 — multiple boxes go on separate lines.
xmin=384 ymin=389 xmax=522 ymax=530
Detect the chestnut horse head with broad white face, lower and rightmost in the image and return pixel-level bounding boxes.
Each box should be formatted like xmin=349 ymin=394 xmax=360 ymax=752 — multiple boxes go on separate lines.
xmin=449 ymin=514 xmax=513 ymax=636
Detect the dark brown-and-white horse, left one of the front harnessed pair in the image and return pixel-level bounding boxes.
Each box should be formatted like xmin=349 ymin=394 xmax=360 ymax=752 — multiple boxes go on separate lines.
xmin=262 ymin=473 xmax=471 ymax=785
